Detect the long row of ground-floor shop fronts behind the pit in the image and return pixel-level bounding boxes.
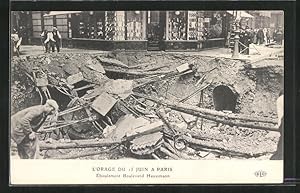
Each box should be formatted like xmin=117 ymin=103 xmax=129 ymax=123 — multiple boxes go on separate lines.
xmin=12 ymin=11 xmax=232 ymax=51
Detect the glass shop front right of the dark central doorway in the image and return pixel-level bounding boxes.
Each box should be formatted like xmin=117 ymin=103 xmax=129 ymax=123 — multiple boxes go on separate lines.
xmin=165 ymin=11 xmax=228 ymax=50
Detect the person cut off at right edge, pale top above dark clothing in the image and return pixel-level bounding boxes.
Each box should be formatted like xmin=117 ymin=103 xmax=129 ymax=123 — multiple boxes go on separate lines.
xmin=270 ymin=90 xmax=284 ymax=160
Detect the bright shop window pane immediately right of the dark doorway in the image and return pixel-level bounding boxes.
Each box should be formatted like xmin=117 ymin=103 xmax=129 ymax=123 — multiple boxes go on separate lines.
xmin=168 ymin=11 xmax=187 ymax=40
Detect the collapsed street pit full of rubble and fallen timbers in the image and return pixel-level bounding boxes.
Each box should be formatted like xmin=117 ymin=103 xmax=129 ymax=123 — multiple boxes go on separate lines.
xmin=11 ymin=48 xmax=284 ymax=159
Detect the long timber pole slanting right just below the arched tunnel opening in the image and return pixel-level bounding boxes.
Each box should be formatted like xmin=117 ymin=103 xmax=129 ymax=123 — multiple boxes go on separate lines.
xmin=134 ymin=93 xmax=278 ymax=131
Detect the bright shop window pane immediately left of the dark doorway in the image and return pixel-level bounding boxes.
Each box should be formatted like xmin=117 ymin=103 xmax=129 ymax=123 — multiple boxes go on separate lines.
xmin=126 ymin=11 xmax=145 ymax=40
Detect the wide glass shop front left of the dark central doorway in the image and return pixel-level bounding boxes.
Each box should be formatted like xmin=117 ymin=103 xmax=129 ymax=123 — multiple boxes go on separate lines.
xmin=71 ymin=11 xmax=147 ymax=50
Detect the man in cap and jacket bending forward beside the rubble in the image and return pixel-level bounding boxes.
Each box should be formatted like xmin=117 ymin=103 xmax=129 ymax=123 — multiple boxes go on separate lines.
xmin=11 ymin=100 xmax=58 ymax=159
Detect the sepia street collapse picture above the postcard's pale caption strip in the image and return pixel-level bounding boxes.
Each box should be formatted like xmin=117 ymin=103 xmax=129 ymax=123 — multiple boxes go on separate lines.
xmin=9 ymin=10 xmax=285 ymax=184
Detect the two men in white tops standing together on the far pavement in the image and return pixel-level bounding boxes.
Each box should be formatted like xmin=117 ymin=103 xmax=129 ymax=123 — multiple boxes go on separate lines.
xmin=41 ymin=26 xmax=61 ymax=53
